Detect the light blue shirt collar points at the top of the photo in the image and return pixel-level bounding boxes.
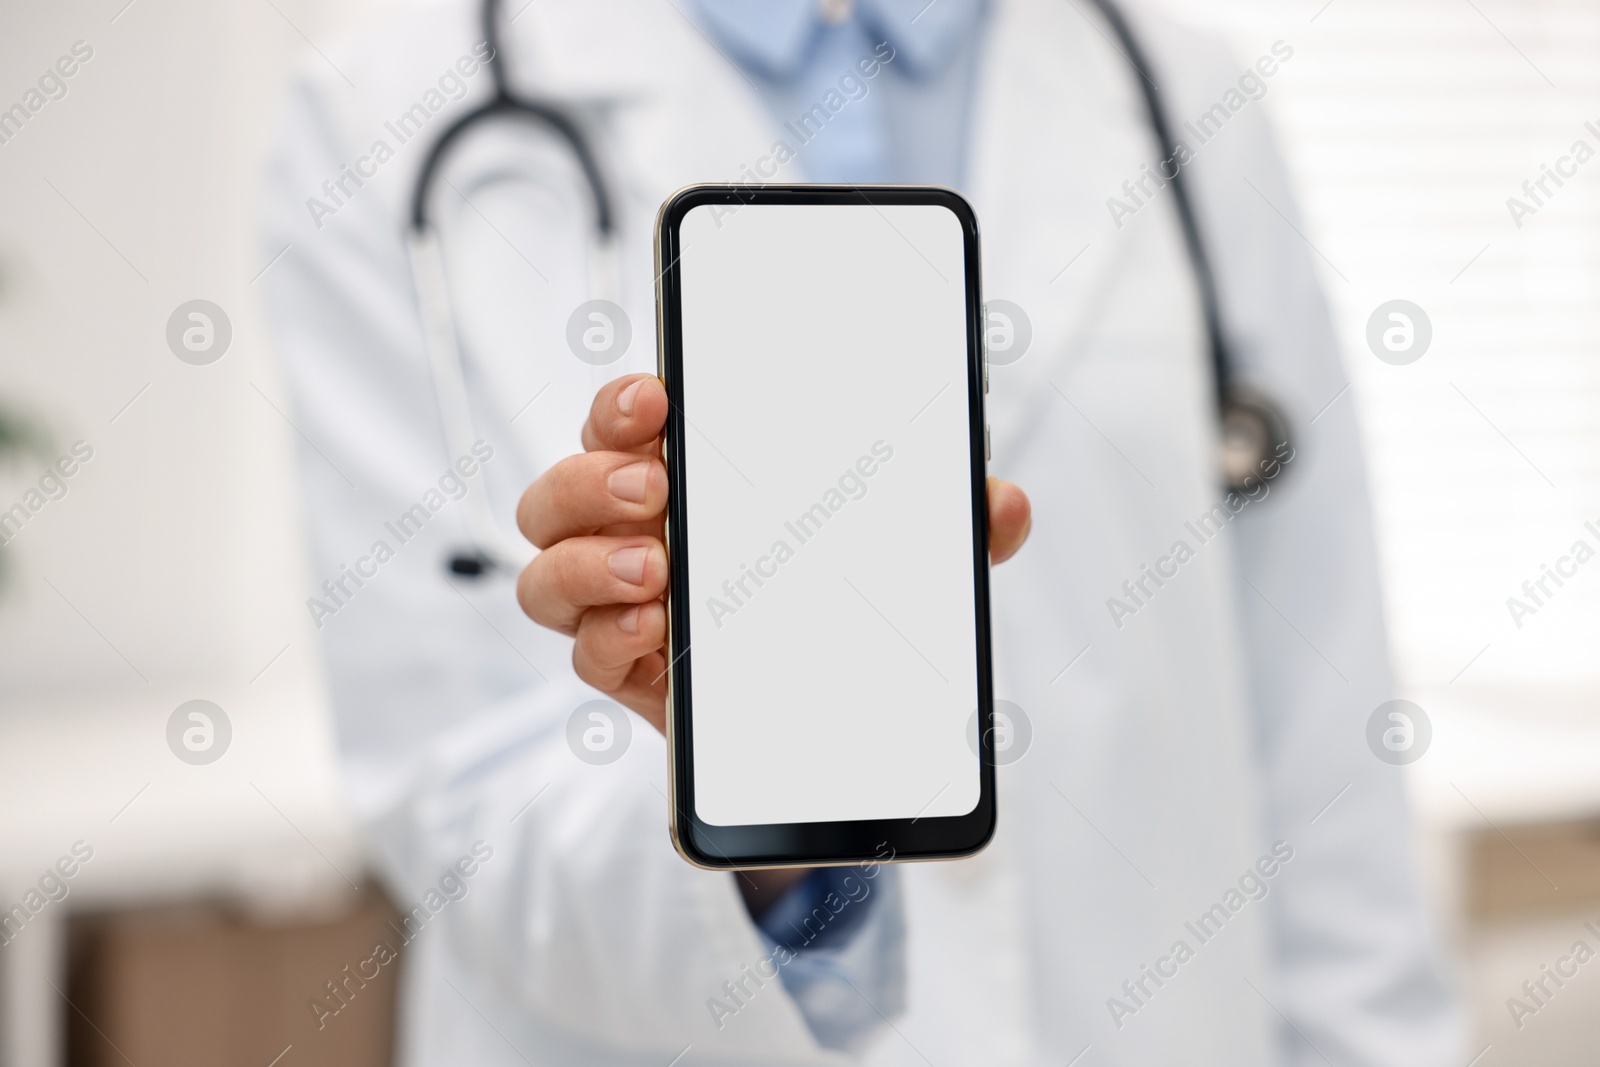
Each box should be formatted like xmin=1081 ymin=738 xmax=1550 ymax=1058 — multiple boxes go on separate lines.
xmin=694 ymin=0 xmax=986 ymax=82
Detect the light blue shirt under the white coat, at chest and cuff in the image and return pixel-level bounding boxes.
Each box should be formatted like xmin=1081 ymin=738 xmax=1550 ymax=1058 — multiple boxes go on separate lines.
xmin=694 ymin=0 xmax=986 ymax=1051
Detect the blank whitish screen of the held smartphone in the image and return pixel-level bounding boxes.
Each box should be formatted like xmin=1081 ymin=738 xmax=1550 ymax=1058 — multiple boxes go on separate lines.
xmin=682 ymin=205 xmax=979 ymax=825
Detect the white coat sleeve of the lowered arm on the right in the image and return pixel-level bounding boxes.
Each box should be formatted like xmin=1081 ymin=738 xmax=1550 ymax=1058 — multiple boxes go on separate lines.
xmin=1162 ymin=18 xmax=1467 ymax=1067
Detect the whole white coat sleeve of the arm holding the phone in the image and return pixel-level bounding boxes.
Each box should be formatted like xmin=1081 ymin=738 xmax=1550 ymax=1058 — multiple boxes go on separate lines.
xmin=262 ymin=48 xmax=876 ymax=1064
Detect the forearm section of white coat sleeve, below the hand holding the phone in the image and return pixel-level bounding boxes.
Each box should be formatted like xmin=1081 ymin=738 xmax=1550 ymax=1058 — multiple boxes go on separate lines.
xmin=371 ymin=683 xmax=827 ymax=1062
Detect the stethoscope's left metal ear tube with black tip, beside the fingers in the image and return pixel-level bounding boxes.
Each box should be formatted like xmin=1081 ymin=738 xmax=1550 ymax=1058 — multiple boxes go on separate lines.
xmin=406 ymin=224 xmax=534 ymax=577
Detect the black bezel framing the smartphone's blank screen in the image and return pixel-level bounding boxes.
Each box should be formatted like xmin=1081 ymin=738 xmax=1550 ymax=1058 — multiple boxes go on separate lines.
xmin=656 ymin=184 xmax=997 ymax=870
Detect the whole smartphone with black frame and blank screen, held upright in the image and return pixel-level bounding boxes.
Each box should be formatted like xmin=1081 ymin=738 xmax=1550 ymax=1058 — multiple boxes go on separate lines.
xmin=656 ymin=186 xmax=995 ymax=869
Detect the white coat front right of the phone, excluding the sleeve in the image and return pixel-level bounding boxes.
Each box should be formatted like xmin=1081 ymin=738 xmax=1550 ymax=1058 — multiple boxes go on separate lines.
xmin=901 ymin=0 xmax=1269 ymax=1064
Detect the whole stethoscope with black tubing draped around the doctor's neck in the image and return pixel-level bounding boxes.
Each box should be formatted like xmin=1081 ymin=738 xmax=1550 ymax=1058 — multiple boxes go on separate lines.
xmin=406 ymin=0 xmax=1291 ymax=577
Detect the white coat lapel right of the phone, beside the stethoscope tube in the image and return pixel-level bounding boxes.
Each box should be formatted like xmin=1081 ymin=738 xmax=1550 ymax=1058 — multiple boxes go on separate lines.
xmin=968 ymin=0 xmax=1198 ymax=483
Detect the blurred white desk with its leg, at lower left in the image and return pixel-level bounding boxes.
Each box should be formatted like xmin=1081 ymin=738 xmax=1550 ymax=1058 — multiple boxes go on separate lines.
xmin=0 ymin=681 xmax=363 ymax=1067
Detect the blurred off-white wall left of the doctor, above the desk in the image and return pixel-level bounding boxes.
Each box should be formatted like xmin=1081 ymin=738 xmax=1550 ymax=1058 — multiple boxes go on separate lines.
xmin=0 ymin=0 xmax=390 ymax=699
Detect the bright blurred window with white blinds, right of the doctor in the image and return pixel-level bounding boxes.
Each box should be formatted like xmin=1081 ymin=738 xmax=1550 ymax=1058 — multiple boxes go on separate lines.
xmin=1158 ymin=0 xmax=1600 ymax=827
